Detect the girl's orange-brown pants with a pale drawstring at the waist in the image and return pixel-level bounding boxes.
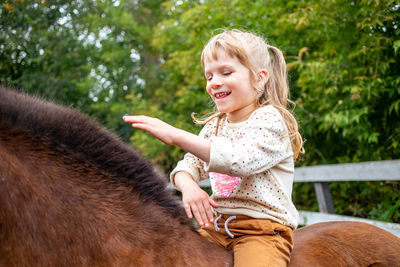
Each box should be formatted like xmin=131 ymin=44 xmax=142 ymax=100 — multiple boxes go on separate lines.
xmin=199 ymin=214 xmax=293 ymax=267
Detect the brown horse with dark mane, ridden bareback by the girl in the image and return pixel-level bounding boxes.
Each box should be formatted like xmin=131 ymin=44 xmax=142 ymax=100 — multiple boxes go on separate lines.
xmin=0 ymin=88 xmax=400 ymax=266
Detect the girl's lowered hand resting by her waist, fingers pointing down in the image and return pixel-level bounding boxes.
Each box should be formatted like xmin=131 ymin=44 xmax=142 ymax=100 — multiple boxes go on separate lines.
xmin=181 ymin=183 xmax=218 ymax=227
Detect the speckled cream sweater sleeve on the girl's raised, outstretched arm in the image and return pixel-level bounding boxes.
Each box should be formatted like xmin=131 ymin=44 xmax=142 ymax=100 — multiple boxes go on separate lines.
xmin=205 ymin=108 xmax=293 ymax=177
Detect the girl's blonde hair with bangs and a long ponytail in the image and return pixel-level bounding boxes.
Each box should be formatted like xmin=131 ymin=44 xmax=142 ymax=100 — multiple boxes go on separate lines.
xmin=192 ymin=30 xmax=304 ymax=159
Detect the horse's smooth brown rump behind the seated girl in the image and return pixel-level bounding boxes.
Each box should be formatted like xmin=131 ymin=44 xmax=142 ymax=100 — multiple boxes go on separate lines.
xmin=290 ymin=222 xmax=400 ymax=266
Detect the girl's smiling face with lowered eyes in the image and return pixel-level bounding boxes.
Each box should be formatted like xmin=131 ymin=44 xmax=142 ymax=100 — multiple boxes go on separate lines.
xmin=204 ymin=48 xmax=256 ymax=122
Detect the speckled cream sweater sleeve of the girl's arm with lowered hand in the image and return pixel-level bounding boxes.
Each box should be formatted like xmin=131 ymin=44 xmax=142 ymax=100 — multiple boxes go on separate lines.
xmin=170 ymin=120 xmax=215 ymax=185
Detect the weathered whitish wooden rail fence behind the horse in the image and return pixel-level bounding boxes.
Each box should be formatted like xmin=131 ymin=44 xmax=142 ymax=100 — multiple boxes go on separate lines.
xmin=200 ymin=160 xmax=400 ymax=237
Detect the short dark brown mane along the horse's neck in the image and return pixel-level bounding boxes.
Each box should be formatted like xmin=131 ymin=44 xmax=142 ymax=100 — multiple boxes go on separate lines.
xmin=0 ymin=86 xmax=188 ymax=223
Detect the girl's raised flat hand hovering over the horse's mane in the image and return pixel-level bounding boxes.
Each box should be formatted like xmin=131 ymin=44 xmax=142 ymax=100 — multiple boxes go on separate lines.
xmin=123 ymin=116 xmax=179 ymax=145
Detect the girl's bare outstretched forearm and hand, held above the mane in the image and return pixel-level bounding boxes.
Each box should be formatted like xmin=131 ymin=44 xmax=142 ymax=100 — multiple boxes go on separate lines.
xmin=123 ymin=116 xmax=211 ymax=163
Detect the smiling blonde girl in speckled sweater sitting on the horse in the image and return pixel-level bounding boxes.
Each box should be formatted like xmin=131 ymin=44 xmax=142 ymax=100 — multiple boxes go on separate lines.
xmin=124 ymin=30 xmax=302 ymax=266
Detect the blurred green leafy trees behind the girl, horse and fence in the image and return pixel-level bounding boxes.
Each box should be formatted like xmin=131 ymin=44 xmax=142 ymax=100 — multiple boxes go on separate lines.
xmin=0 ymin=0 xmax=400 ymax=223
